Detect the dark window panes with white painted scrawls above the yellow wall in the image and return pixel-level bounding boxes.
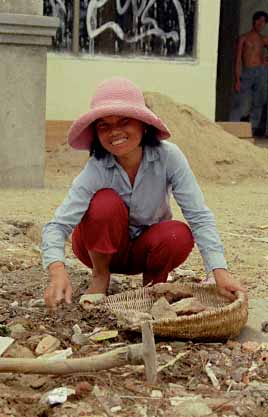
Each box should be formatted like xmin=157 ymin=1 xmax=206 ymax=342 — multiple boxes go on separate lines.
xmin=44 ymin=0 xmax=196 ymax=57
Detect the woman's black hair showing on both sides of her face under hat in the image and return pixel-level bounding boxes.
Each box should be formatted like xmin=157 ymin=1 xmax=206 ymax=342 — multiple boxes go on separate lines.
xmin=89 ymin=125 xmax=161 ymax=159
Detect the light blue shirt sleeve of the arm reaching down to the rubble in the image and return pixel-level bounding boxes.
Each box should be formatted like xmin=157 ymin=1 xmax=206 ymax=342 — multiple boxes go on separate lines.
xmin=42 ymin=161 xmax=104 ymax=269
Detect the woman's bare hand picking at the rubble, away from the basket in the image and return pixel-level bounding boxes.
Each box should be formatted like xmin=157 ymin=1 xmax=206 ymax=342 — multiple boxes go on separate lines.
xmin=44 ymin=262 xmax=72 ymax=310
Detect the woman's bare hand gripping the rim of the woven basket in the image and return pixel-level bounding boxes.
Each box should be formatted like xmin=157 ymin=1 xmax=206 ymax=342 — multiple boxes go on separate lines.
xmin=213 ymin=268 xmax=247 ymax=301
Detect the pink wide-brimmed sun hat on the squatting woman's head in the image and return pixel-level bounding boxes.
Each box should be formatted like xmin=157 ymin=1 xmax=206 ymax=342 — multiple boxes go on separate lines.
xmin=68 ymin=77 xmax=170 ymax=150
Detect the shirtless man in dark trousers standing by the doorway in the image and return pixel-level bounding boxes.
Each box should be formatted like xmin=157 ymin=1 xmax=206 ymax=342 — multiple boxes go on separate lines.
xmin=230 ymin=11 xmax=268 ymax=135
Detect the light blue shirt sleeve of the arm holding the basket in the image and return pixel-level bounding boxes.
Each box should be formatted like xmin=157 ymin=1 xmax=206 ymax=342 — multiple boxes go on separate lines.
xmin=167 ymin=144 xmax=227 ymax=273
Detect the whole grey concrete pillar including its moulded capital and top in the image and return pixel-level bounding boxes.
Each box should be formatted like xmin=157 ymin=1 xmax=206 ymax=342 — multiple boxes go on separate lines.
xmin=0 ymin=0 xmax=59 ymax=188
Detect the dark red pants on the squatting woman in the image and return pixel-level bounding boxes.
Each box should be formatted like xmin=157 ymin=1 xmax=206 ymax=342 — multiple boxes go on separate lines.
xmin=72 ymin=189 xmax=194 ymax=284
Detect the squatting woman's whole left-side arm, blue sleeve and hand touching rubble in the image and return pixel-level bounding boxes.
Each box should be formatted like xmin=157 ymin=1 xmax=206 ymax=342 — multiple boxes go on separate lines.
xmin=42 ymin=164 xmax=104 ymax=309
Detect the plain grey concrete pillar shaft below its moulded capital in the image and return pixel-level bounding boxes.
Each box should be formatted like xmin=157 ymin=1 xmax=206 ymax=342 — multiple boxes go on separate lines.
xmin=0 ymin=44 xmax=46 ymax=187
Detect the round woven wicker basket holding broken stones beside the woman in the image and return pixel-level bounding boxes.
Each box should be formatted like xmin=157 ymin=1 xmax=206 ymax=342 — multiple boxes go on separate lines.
xmin=104 ymin=283 xmax=248 ymax=341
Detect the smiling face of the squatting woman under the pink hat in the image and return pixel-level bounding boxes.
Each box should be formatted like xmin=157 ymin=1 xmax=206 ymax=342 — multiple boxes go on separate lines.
xmin=95 ymin=116 xmax=144 ymax=157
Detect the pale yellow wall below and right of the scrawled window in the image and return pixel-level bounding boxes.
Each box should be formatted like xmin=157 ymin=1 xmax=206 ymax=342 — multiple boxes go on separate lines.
xmin=46 ymin=0 xmax=220 ymax=120
